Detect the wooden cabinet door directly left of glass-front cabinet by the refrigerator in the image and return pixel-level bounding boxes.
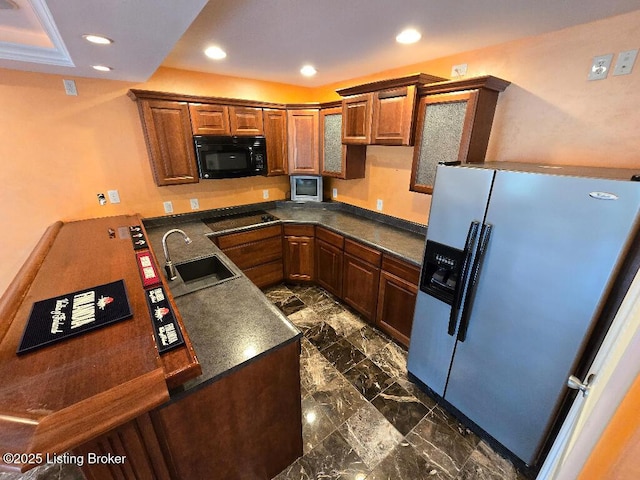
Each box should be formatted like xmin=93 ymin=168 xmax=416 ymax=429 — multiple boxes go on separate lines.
xmin=371 ymin=85 xmax=416 ymax=145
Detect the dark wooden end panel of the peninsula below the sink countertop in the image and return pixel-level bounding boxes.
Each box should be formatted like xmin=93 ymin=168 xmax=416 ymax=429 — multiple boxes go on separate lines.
xmin=73 ymin=340 xmax=303 ymax=480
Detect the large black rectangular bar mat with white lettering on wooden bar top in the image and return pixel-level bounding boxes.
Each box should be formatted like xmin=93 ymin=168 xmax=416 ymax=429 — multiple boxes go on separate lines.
xmin=17 ymin=280 xmax=132 ymax=355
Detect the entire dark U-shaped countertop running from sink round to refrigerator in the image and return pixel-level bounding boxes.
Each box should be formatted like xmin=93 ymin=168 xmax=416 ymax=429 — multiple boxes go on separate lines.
xmin=144 ymin=202 xmax=426 ymax=396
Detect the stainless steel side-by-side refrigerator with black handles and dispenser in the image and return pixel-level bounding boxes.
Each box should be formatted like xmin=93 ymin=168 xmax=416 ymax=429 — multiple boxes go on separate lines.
xmin=408 ymin=166 xmax=640 ymax=465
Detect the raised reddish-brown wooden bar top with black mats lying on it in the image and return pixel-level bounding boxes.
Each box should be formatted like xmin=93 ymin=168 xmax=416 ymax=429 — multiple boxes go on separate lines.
xmin=0 ymin=215 xmax=201 ymax=471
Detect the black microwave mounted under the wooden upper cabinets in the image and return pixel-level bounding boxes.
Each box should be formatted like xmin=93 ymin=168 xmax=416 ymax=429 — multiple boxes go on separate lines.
xmin=193 ymin=135 xmax=267 ymax=178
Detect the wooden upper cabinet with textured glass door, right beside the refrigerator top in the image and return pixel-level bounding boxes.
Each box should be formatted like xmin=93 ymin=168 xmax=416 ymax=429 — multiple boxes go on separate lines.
xmin=410 ymin=76 xmax=509 ymax=193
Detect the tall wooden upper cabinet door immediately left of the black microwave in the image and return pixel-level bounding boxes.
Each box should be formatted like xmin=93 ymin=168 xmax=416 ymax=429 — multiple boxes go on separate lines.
xmin=138 ymin=99 xmax=199 ymax=186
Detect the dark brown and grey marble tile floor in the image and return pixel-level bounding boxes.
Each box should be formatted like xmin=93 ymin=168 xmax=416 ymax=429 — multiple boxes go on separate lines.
xmin=265 ymin=285 xmax=526 ymax=480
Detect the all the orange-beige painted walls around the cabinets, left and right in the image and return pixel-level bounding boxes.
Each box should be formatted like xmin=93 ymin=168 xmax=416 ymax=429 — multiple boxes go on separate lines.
xmin=0 ymin=11 xmax=640 ymax=291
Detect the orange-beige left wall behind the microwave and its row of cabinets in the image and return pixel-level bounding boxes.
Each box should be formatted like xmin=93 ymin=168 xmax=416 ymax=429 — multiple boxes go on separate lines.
xmin=0 ymin=69 xmax=310 ymax=292
